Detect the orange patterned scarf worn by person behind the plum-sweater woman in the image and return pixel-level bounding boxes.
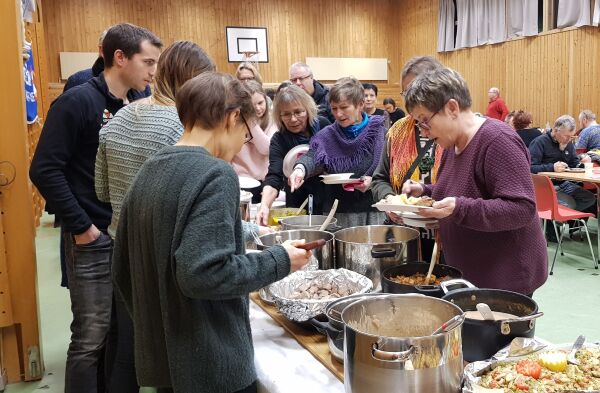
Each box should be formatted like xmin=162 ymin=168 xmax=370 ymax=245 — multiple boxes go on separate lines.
xmin=387 ymin=115 xmax=443 ymax=194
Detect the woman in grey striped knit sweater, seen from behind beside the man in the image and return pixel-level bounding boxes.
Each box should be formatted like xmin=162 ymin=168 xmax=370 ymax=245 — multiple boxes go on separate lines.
xmin=95 ymin=41 xmax=215 ymax=393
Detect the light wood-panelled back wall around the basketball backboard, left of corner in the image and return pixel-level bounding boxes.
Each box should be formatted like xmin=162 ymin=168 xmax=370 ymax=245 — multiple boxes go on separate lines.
xmin=42 ymin=0 xmax=397 ymax=82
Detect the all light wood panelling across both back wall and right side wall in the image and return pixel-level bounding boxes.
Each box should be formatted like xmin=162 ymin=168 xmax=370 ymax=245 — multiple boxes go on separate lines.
xmin=42 ymin=0 xmax=600 ymax=125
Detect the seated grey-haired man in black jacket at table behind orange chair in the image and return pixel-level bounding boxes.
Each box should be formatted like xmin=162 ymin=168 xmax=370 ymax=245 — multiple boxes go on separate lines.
xmin=529 ymin=115 xmax=596 ymax=211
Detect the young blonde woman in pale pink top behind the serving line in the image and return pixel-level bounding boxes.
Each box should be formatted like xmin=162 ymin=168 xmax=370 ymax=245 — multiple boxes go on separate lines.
xmin=231 ymin=80 xmax=277 ymax=203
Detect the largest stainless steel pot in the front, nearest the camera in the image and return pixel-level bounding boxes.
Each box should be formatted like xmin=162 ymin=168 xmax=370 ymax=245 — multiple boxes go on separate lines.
xmin=342 ymin=294 xmax=463 ymax=393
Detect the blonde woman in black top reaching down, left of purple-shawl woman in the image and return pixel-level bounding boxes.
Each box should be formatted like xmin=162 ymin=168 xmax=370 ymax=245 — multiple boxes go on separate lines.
xmin=256 ymin=84 xmax=330 ymax=225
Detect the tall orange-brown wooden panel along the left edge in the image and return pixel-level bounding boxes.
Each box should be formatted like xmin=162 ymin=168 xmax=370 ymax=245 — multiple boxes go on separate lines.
xmin=0 ymin=1 xmax=43 ymax=382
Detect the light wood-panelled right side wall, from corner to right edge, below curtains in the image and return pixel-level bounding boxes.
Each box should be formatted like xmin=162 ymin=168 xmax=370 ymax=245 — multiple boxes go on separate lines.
xmin=392 ymin=0 xmax=600 ymax=125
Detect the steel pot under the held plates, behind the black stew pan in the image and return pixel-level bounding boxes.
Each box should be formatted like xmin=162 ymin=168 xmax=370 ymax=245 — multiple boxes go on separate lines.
xmin=335 ymin=225 xmax=420 ymax=291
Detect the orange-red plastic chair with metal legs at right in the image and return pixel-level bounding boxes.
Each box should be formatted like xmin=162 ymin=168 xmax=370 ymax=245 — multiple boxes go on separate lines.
xmin=532 ymin=175 xmax=598 ymax=274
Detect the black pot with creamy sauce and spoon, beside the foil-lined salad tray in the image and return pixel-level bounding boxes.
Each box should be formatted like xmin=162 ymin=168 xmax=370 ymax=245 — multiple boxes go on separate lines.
xmin=440 ymin=279 xmax=544 ymax=362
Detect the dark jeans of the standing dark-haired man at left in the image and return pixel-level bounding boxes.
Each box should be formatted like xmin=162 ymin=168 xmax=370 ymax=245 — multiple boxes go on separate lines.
xmin=64 ymin=232 xmax=113 ymax=393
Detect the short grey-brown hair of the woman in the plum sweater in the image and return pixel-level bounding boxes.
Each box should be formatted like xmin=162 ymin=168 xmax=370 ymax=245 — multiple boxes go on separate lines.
xmin=405 ymin=68 xmax=471 ymax=112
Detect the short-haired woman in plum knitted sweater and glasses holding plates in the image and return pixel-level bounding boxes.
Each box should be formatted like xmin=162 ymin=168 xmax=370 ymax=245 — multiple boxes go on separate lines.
xmin=403 ymin=68 xmax=548 ymax=295
